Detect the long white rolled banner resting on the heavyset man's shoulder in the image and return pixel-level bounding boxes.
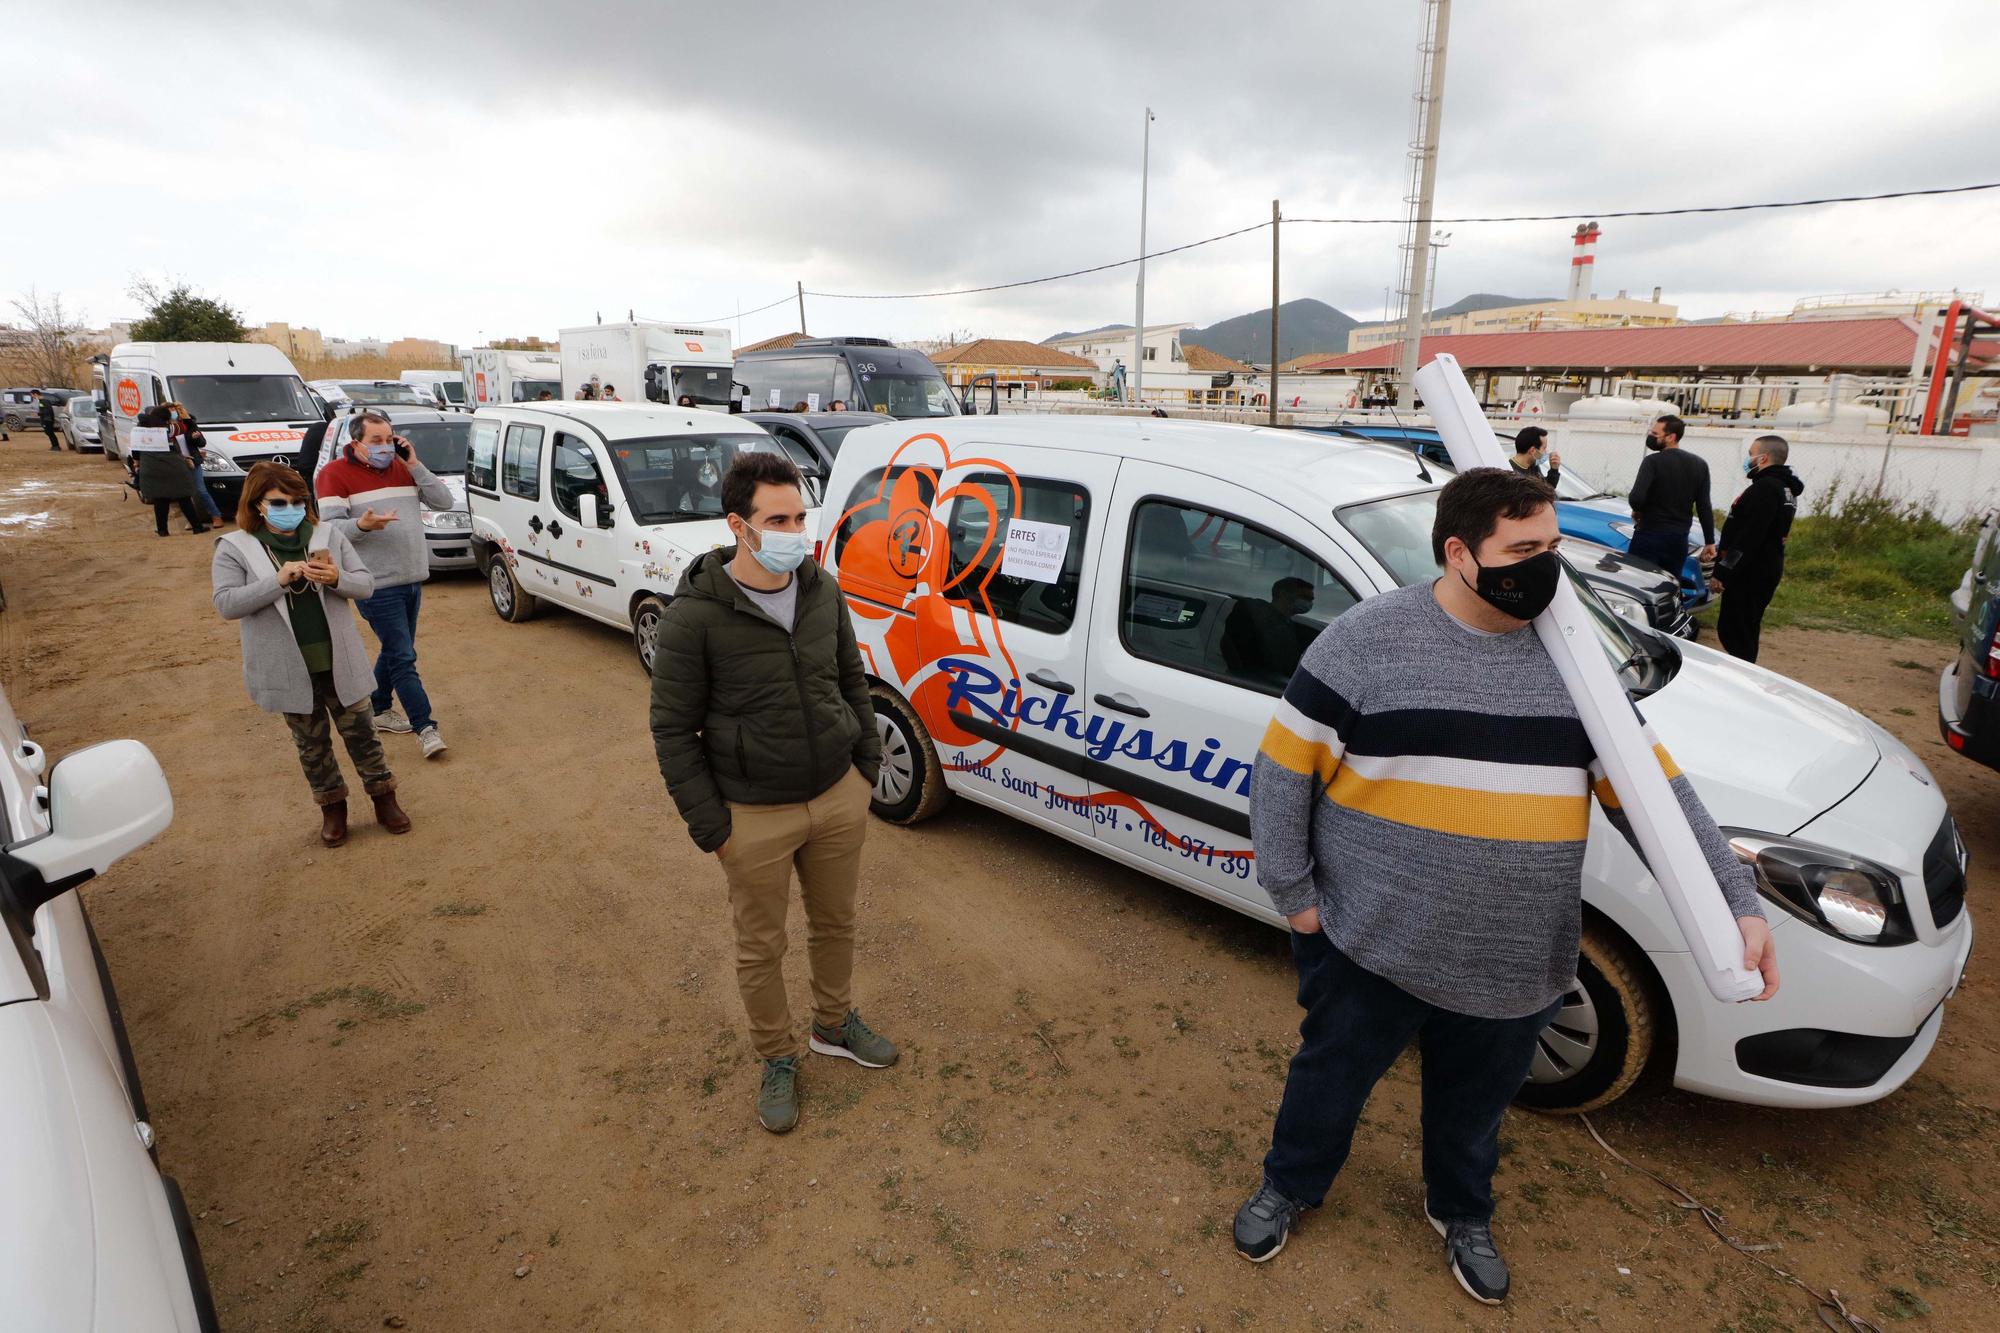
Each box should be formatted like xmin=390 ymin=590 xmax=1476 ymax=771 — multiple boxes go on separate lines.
xmin=1416 ymin=356 xmax=1764 ymax=1001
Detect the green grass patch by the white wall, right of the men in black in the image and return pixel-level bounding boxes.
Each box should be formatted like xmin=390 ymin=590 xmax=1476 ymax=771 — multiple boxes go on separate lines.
xmin=1764 ymin=486 xmax=1978 ymax=642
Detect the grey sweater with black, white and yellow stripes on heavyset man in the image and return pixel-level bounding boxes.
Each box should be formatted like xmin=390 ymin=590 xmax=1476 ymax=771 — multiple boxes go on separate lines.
xmin=1250 ymin=584 xmax=1760 ymax=1019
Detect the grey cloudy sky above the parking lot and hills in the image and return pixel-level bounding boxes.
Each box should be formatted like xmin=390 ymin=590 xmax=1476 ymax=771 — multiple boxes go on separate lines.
xmin=0 ymin=0 xmax=2000 ymax=344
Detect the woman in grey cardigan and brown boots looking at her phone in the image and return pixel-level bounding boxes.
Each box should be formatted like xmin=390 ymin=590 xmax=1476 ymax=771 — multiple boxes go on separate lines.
xmin=210 ymin=462 xmax=410 ymax=847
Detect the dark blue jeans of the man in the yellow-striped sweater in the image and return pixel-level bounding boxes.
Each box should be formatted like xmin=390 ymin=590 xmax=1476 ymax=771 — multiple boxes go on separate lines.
xmin=1264 ymin=931 xmax=1562 ymax=1221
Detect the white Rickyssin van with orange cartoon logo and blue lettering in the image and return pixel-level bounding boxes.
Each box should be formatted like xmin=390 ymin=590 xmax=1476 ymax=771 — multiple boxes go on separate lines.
xmin=822 ymin=416 xmax=1972 ymax=1109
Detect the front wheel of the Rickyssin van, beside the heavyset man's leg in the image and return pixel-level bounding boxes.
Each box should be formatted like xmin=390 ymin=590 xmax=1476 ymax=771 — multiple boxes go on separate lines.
xmin=1514 ymin=919 xmax=1660 ymax=1115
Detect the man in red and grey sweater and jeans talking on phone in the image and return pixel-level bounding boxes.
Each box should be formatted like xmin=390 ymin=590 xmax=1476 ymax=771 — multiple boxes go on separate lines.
xmin=314 ymin=412 xmax=456 ymax=759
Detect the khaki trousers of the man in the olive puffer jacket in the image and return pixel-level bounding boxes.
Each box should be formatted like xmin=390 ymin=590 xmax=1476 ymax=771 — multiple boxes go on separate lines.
xmin=722 ymin=769 xmax=872 ymax=1061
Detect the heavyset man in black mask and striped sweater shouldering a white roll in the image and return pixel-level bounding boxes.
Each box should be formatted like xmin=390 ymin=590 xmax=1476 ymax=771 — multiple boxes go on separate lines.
xmin=1236 ymin=468 xmax=1778 ymax=1305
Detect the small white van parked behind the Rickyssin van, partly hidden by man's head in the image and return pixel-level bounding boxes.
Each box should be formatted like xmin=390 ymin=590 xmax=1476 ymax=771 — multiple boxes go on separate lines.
xmin=466 ymin=402 xmax=812 ymax=673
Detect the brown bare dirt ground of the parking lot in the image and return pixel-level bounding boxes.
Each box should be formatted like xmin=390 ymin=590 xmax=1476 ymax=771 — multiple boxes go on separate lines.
xmin=0 ymin=436 xmax=2000 ymax=1331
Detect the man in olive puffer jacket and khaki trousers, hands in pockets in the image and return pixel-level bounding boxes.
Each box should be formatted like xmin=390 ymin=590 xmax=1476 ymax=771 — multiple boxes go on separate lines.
xmin=652 ymin=452 xmax=896 ymax=1133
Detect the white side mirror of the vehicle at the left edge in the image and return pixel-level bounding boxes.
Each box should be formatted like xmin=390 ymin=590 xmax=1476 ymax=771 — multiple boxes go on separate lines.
xmin=10 ymin=741 xmax=174 ymax=917
